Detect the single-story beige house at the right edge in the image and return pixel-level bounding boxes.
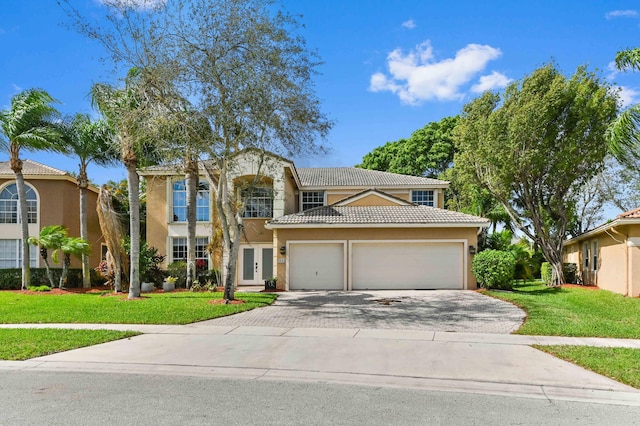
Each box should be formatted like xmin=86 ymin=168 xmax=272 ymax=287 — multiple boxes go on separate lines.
xmin=563 ymin=208 xmax=640 ymax=297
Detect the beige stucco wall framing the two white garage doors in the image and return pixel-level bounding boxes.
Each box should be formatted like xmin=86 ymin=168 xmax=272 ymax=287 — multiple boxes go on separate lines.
xmin=274 ymin=228 xmax=477 ymax=290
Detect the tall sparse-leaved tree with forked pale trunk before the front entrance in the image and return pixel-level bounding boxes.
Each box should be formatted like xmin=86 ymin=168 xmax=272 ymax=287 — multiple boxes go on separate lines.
xmin=63 ymin=0 xmax=332 ymax=299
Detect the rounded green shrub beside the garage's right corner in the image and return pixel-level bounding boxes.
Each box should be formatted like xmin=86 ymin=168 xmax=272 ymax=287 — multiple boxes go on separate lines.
xmin=471 ymin=250 xmax=516 ymax=290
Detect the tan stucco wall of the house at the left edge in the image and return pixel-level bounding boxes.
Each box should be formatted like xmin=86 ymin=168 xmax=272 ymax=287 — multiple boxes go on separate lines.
xmin=0 ymin=177 xmax=104 ymax=268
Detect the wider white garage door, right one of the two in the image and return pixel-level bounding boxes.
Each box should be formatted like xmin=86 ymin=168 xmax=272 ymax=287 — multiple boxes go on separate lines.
xmin=351 ymin=241 xmax=464 ymax=290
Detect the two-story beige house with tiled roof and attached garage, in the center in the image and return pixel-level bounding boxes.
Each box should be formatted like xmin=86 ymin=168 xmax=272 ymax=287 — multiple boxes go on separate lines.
xmin=140 ymin=151 xmax=489 ymax=290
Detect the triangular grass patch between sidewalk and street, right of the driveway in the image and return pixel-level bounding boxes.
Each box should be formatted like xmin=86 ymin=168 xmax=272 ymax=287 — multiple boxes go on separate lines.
xmin=534 ymin=345 xmax=640 ymax=389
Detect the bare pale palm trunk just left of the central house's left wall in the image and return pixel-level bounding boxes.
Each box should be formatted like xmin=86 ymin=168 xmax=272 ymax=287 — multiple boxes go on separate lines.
xmin=125 ymin=161 xmax=140 ymax=299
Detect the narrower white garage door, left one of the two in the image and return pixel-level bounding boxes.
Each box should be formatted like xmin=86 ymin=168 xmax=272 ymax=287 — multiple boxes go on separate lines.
xmin=289 ymin=243 xmax=345 ymax=290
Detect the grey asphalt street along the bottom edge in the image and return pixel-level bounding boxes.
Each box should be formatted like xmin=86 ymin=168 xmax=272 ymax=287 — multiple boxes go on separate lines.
xmin=0 ymin=371 xmax=640 ymax=425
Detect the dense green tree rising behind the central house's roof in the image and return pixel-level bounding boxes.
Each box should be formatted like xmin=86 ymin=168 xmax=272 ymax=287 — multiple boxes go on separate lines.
xmin=358 ymin=116 xmax=458 ymax=178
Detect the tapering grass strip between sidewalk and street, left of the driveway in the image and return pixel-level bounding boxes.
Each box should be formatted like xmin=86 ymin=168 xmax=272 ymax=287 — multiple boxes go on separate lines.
xmin=0 ymin=328 xmax=140 ymax=361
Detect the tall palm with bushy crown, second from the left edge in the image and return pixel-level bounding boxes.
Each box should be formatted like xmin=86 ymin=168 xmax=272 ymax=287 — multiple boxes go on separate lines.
xmin=64 ymin=114 xmax=118 ymax=288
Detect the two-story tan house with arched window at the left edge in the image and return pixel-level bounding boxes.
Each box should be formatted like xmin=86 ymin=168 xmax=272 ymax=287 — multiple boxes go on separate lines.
xmin=0 ymin=160 xmax=103 ymax=268
